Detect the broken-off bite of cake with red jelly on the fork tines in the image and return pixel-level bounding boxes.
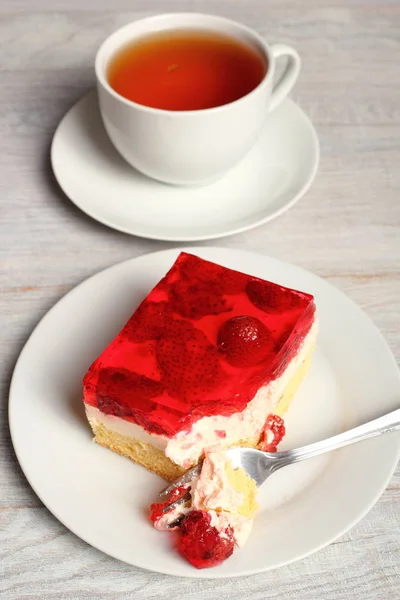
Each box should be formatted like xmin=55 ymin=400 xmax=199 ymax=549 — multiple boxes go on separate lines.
xmin=150 ymin=446 xmax=258 ymax=569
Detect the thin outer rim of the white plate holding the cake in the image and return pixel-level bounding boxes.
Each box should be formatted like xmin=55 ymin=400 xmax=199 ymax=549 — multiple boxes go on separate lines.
xmin=8 ymin=246 xmax=400 ymax=579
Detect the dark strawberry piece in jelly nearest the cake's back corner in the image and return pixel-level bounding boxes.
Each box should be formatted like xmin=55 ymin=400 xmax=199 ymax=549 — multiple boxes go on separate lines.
xmin=170 ymin=281 xmax=231 ymax=319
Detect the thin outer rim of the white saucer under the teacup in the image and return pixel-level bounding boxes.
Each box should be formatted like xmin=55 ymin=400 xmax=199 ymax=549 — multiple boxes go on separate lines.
xmin=50 ymin=95 xmax=320 ymax=242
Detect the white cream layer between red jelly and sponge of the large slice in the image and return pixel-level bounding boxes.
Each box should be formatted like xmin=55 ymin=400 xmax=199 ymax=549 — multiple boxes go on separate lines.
xmin=85 ymin=319 xmax=318 ymax=469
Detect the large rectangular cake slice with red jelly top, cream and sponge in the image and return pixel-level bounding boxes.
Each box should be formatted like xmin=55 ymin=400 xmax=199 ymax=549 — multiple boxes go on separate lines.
xmin=84 ymin=253 xmax=317 ymax=480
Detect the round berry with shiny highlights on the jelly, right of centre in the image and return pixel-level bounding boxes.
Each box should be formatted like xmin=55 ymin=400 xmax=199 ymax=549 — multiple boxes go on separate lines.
xmin=218 ymin=316 xmax=275 ymax=368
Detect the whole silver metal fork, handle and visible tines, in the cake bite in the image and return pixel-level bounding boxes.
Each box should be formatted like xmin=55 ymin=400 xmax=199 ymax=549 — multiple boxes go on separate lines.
xmin=159 ymin=408 xmax=400 ymax=512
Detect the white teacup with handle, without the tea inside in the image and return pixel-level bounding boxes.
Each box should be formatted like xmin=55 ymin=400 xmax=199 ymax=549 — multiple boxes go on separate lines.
xmin=95 ymin=13 xmax=300 ymax=185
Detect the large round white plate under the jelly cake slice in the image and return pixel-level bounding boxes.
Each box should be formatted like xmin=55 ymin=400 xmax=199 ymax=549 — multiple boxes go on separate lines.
xmin=9 ymin=248 xmax=400 ymax=578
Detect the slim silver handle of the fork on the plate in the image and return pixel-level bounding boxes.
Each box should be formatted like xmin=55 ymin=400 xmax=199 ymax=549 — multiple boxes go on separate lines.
xmin=274 ymin=408 xmax=400 ymax=470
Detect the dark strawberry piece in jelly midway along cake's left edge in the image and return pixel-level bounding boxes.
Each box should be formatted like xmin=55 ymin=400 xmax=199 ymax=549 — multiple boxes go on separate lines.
xmin=123 ymin=300 xmax=170 ymax=343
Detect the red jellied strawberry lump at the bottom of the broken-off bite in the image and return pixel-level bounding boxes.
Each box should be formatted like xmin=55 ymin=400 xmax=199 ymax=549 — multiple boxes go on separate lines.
xmin=179 ymin=510 xmax=235 ymax=569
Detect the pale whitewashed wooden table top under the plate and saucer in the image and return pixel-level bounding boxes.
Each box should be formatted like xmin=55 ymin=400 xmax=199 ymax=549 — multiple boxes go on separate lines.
xmin=0 ymin=0 xmax=400 ymax=600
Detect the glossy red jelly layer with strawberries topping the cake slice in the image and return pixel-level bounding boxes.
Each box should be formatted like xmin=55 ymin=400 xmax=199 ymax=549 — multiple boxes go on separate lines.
xmin=83 ymin=253 xmax=315 ymax=437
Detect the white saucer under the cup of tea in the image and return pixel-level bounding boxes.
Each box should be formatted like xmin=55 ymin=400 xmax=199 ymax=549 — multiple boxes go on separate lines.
xmin=51 ymin=92 xmax=319 ymax=241
